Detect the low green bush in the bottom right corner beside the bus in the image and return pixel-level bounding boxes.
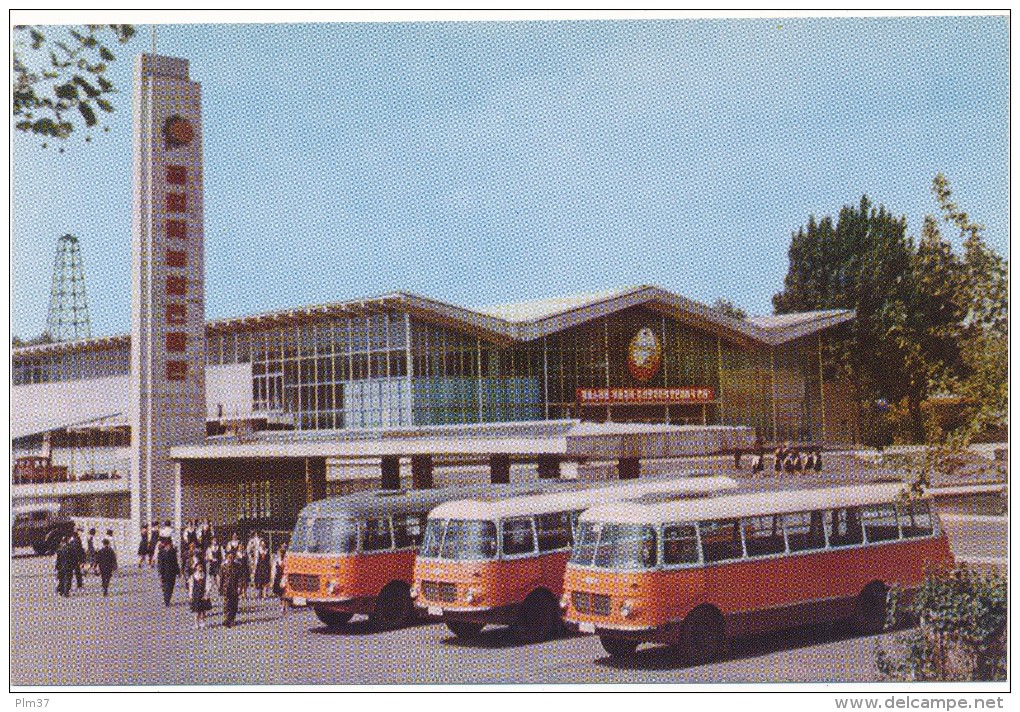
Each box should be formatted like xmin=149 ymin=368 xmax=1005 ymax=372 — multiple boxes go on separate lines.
xmin=876 ymin=566 xmax=1009 ymax=682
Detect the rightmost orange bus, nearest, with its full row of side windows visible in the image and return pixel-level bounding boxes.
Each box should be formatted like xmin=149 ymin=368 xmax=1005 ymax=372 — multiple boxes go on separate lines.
xmin=560 ymin=482 xmax=953 ymax=664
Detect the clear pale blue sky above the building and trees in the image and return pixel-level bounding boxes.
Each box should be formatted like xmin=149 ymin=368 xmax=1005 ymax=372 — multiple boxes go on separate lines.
xmin=10 ymin=15 xmax=1009 ymax=338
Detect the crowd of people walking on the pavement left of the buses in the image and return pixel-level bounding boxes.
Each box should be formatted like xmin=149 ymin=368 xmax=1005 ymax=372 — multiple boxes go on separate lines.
xmin=55 ymin=520 xmax=288 ymax=628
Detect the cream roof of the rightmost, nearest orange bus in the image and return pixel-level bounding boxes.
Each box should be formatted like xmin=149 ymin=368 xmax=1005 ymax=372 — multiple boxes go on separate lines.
xmin=580 ymin=482 xmax=906 ymax=524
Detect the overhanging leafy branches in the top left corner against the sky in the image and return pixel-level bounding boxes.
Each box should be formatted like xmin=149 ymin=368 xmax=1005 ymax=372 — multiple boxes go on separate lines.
xmin=11 ymin=24 xmax=135 ymax=147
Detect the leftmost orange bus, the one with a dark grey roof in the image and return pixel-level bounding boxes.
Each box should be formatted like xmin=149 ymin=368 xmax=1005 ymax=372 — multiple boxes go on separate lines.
xmin=284 ymin=480 xmax=578 ymax=630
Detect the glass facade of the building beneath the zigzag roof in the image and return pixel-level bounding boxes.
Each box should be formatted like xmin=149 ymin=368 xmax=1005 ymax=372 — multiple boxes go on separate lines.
xmin=13 ymin=306 xmax=823 ymax=442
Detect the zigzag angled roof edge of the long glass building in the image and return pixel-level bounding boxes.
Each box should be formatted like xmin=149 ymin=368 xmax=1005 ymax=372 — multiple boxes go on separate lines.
xmin=12 ymin=286 xmax=854 ymax=356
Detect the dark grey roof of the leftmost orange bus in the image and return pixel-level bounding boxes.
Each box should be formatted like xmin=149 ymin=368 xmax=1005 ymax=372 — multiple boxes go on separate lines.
xmin=298 ymin=479 xmax=578 ymax=519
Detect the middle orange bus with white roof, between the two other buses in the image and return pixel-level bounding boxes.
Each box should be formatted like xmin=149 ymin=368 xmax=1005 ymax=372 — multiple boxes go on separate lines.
xmin=411 ymin=476 xmax=736 ymax=642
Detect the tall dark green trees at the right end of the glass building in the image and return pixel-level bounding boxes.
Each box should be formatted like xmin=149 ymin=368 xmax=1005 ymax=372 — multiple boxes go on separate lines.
xmin=772 ymin=178 xmax=1009 ymax=445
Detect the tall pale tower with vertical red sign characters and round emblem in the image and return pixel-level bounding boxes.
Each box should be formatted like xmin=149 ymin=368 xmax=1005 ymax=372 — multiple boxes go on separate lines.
xmin=130 ymin=54 xmax=205 ymax=522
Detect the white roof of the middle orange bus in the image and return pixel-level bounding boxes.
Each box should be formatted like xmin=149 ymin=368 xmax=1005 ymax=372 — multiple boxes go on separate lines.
xmin=429 ymin=476 xmax=737 ymax=521
